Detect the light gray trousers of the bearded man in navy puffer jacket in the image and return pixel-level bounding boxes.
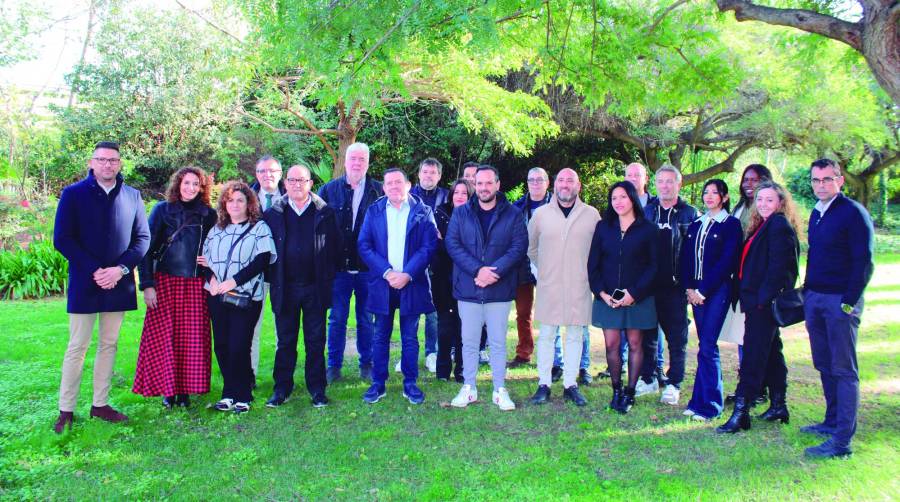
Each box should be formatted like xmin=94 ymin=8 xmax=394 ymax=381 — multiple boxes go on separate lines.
xmin=459 ymin=301 xmax=510 ymax=390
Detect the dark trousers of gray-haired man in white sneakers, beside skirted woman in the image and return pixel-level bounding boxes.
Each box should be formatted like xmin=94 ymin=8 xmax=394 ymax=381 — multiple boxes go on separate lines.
xmin=641 ymin=286 xmax=688 ymax=388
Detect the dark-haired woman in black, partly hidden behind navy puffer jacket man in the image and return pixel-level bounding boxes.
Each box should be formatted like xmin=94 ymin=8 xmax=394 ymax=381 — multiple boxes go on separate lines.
xmin=431 ymin=179 xmax=474 ymax=383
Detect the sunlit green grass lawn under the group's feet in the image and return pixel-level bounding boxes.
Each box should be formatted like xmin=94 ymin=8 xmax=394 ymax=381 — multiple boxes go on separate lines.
xmin=0 ymin=255 xmax=900 ymax=500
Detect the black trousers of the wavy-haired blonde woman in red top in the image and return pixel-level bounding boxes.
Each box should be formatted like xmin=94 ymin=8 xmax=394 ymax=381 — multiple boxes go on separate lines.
xmin=735 ymin=298 xmax=787 ymax=399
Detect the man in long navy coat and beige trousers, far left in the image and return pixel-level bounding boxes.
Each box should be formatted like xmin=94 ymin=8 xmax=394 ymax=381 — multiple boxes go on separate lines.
xmin=53 ymin=141 xmax=150 ymax=434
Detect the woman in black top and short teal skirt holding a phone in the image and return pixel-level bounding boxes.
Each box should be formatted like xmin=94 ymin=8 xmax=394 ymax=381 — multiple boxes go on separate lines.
xmin=588 ymin=181 xmax=657 ymax=413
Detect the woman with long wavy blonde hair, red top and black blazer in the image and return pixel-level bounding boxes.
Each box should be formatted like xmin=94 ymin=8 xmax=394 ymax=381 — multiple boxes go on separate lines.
xmin=716 ymin=182 xmax=800 ymax=433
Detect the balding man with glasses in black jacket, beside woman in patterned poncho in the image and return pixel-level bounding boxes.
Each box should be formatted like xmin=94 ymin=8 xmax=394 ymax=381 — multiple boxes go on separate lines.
xmin=263 ymin=165 xmax=341 ymax=408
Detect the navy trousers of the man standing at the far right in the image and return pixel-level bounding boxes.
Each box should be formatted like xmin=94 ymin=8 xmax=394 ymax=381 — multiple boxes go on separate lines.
xmin=803 ymin=290 xmax=863 ymax=447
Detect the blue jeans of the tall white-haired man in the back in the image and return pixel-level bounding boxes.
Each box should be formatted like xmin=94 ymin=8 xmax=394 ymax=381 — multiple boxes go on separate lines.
xmin=328 ymin=272 xmax=375 ymax=368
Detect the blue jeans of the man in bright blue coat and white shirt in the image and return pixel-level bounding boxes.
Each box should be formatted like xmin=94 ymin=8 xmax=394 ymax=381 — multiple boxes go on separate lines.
xmin=372 ymin=289 xmax=419 ymax=386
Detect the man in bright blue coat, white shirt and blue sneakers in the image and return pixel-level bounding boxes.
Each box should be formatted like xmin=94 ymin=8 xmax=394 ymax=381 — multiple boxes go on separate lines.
xmin=358 ymin=168 xmax=437 ymax=404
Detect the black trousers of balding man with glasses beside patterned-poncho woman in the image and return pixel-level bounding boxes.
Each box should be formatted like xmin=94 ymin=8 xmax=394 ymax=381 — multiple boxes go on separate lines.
xmin=272 ymin=284 xmax=326 ymax=397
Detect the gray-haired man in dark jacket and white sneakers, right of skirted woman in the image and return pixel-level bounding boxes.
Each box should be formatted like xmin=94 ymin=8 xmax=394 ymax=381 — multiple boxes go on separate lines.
xmin=635 ymin=164 xmax=697 ymax=406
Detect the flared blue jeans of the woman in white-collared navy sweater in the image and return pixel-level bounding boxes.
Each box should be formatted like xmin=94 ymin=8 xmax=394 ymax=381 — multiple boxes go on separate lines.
xmin=688 ymin=286 xmax=729 ymax=418
